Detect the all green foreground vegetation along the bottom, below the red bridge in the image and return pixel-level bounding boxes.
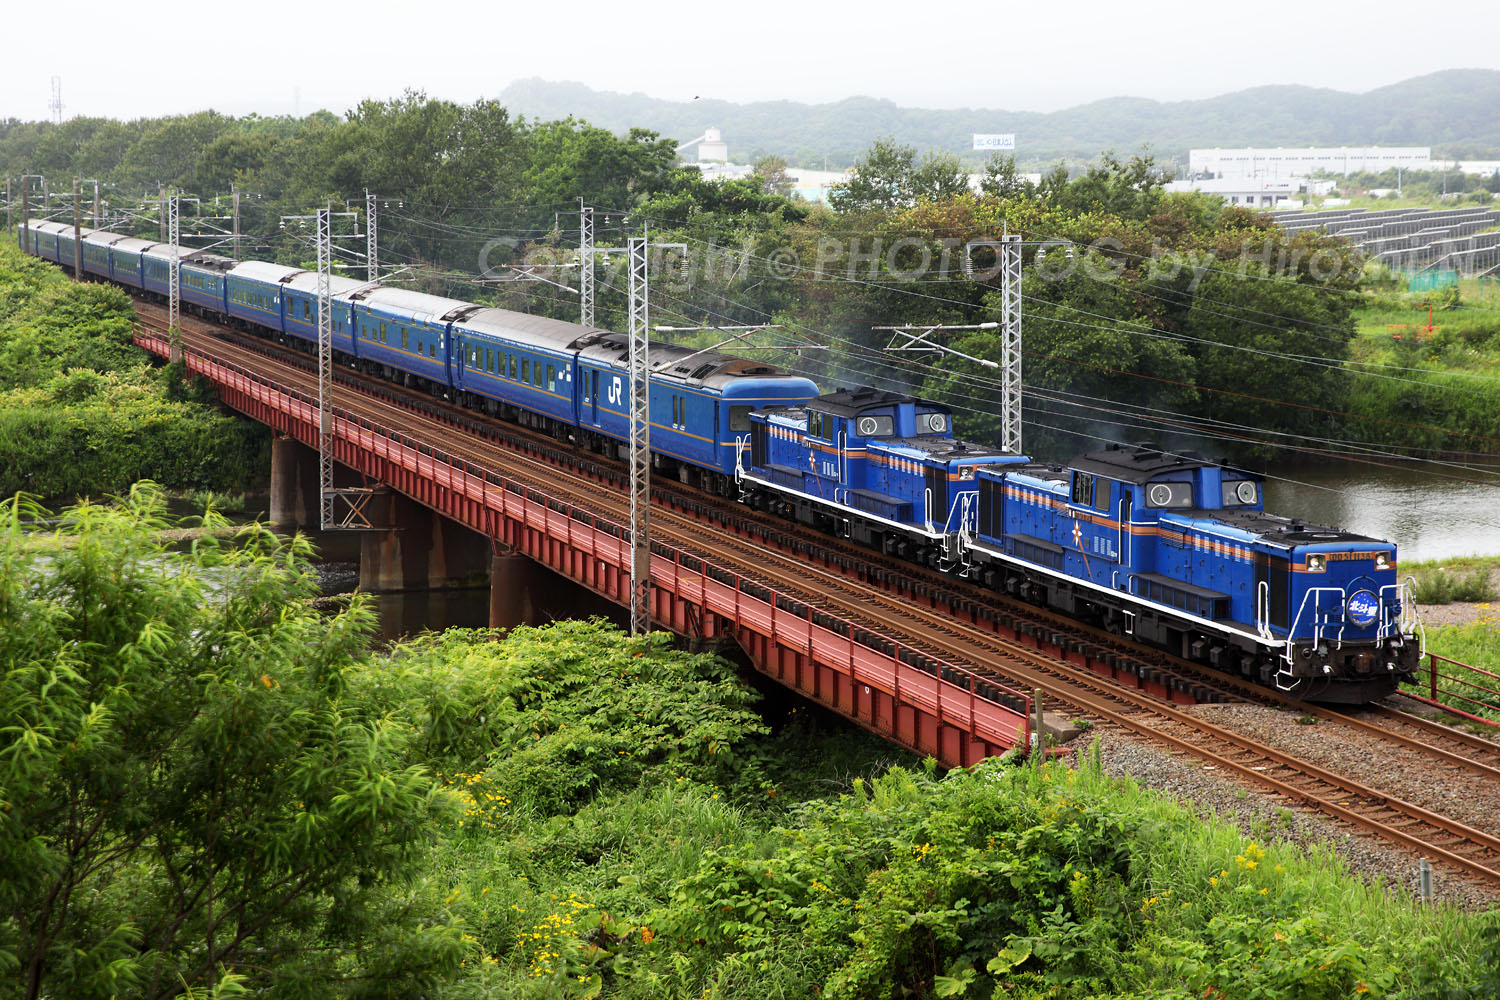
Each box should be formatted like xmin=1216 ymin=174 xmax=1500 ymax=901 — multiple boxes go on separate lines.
xmin=0 ymin=487 xmax=1500 ymax=1000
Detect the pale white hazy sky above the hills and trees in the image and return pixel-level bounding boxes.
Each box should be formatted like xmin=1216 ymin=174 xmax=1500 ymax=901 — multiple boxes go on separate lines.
xmin=0 ymin=0 xmax=1500 ymax=118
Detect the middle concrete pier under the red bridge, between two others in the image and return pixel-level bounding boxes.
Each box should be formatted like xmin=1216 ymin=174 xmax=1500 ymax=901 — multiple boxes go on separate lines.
xmin=360 ymin=493 xmax=491 ymax=592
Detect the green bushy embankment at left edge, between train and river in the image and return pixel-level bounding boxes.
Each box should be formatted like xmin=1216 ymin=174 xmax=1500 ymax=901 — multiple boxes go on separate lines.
xmin=0 ymin=244 xmax=269 ymax=496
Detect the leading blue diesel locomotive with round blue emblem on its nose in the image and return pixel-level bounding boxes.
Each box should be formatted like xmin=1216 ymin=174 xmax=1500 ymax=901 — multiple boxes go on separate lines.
xmin=968 ymin=448 xmax=1419 ymax=702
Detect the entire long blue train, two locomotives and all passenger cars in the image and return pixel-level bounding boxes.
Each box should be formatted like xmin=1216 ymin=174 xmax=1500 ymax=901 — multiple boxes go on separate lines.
xmin=18 ymin=222 xmax=1422 ymax=703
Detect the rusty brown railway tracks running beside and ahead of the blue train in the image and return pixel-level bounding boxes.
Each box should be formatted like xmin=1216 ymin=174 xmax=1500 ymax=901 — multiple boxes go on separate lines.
xmin=135 ymin=302 xmax=1500 ymax=885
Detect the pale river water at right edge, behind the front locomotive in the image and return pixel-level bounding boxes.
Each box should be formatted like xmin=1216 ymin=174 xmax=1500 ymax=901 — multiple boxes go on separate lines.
xmin=1266 ymin=462 xmax=1500 ymax=561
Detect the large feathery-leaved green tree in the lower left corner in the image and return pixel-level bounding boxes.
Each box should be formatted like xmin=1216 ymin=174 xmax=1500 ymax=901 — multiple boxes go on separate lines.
xmin=0 ymin=486 xmax=461 ymax=999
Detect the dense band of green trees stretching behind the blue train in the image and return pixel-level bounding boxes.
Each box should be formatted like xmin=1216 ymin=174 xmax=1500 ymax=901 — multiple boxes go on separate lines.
xmin=0 ymin=93 xmax=1500 ymax=470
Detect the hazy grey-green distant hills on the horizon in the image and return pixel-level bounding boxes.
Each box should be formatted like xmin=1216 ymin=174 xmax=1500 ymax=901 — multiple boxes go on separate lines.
xmin=501 ymin=69 xmax=1500 ymax=166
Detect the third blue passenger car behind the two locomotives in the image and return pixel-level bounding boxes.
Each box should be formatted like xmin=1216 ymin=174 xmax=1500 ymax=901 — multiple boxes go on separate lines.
xmin=347 ymin=286 xmax=480 ymax=385
